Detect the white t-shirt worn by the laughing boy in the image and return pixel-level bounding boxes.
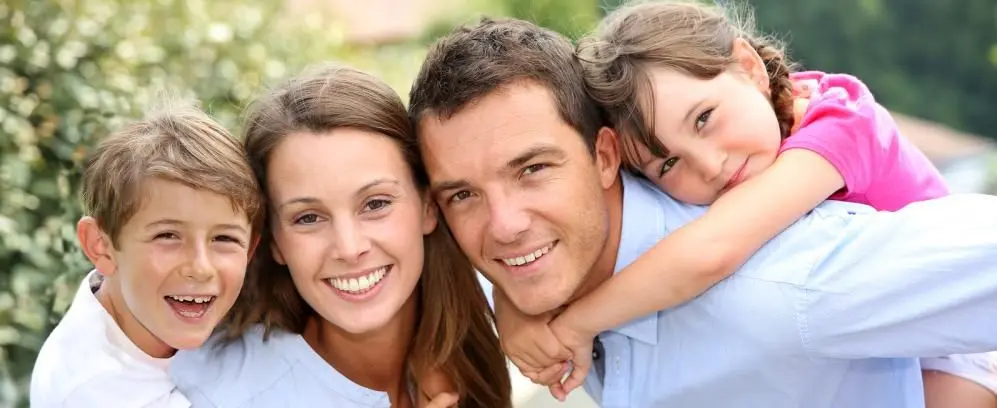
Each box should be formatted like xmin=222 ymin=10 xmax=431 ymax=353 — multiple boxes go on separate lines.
xmin=31 ymin=271 xmax=190 ymax=408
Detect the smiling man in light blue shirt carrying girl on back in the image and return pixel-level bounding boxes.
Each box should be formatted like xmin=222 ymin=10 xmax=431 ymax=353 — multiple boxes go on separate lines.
xmin=409 ymin=20 xmax=997 ymax=408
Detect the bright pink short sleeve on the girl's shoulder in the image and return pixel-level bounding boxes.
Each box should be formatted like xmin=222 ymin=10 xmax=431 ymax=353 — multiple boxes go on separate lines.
xmin=780 ymin=84 xmax=891 ymax=195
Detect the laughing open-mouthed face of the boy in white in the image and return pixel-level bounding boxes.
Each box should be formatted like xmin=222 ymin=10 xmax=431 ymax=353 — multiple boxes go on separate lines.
xmin=97 ymin=179 xmax=252 ymax=354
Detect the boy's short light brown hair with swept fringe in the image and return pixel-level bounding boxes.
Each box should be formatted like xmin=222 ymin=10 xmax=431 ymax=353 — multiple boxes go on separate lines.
xmin=80 ymin=98 xmax=263 ymax=247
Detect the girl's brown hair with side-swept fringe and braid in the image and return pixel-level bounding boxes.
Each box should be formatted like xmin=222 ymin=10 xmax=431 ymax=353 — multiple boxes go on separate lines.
xmin=576 ymin=1 xmax=793 ymax=167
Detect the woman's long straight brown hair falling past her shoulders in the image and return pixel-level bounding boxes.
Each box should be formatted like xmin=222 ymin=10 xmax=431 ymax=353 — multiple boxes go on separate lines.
xmin=226 ymin=65 xmax=511 ymax=408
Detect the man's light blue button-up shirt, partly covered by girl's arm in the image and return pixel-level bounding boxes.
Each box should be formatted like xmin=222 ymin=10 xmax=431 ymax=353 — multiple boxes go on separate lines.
xmin=585 ymin=175 xmax=997 ymax=408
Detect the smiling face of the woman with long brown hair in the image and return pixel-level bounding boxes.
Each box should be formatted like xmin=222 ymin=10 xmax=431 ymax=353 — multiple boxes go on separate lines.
xmin=267 ymin=128 xmax=436 ymax=334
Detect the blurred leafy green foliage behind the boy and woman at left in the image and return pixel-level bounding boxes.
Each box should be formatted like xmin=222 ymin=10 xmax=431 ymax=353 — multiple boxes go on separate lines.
xmin=0 ymin=0 xmax=424 ymax=407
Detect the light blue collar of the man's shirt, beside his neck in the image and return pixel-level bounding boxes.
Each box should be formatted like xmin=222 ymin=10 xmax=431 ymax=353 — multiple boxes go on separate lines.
xmin=610 ymin=171 xmax=667 ymax=346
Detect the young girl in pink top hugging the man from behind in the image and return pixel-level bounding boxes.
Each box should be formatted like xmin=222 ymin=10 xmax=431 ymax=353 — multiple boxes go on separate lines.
xmin=499 ymin=2 xmax=997 ymax=408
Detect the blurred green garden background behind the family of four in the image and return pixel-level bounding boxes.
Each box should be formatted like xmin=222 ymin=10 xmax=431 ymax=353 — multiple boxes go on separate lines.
xmin=0 ymin=0 xmax=997 ymax=408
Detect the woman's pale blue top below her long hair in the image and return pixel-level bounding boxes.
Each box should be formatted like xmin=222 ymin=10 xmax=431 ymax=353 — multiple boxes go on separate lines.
xmin=170 ymin=326 xmax=391 ymax=408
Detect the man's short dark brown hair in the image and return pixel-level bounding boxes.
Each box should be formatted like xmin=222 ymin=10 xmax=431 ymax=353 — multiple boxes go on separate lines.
xmin=409 ymin=18 xmax=606 ymax=149
